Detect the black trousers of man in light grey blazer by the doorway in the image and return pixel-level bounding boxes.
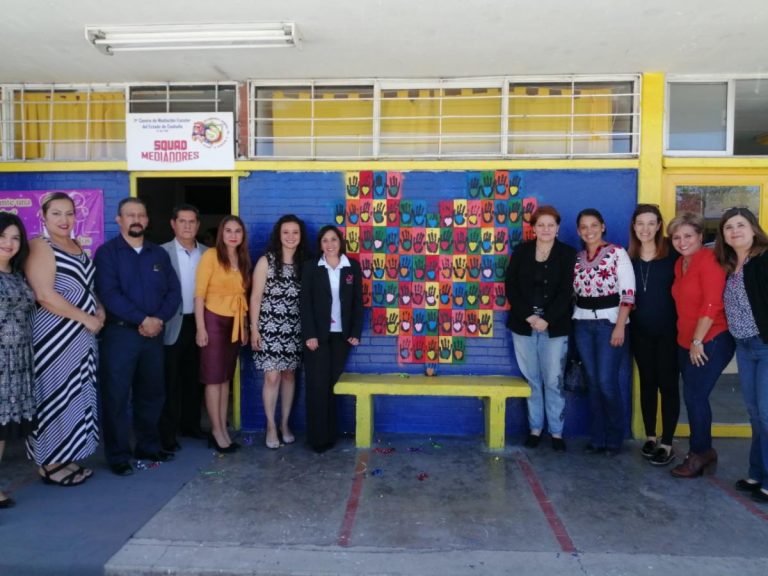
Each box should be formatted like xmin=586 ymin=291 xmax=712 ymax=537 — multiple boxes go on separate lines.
xmin=160 ymin=314 xmax=203 ymax=446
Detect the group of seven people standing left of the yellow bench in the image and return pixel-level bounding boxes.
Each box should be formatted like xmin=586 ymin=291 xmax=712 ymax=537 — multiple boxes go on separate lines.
xmin=0 ymin=192 xmax=362 ymax=508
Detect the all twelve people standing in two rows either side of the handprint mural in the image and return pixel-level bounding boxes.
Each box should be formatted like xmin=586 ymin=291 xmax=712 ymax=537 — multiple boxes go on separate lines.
xmin=0 ymin=192 xmax=768 ymax=508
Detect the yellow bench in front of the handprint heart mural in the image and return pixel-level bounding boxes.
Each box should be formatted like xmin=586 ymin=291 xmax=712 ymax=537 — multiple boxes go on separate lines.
xmin=333 ymin=372 xmax=531 ymax=450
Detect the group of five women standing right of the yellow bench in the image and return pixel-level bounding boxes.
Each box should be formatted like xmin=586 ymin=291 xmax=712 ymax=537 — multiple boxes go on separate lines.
xmin=506 ymin=204 xmax=768 ymax=502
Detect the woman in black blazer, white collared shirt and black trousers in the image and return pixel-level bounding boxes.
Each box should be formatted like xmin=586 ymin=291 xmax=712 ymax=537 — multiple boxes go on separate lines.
xmin=301 ymin=226 xmax=363 ymax=452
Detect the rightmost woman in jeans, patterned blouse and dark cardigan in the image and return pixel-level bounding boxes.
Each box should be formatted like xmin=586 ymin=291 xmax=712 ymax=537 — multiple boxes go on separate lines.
xmin=715 ymin=208 xmax=768 ymax=503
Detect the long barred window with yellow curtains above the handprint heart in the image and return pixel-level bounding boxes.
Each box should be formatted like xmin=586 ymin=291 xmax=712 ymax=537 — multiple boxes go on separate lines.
xmin=249 ymin=76 xmax=640 ymax=159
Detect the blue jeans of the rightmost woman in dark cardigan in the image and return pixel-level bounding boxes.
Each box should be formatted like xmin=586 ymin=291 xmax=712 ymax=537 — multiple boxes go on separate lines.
xmin=736 ymin=336 xmax=768 ymax=486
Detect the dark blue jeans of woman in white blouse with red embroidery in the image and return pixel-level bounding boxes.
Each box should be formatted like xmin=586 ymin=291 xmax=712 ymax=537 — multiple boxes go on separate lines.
xmin=574 ymin=320 xmax=627 ymax=450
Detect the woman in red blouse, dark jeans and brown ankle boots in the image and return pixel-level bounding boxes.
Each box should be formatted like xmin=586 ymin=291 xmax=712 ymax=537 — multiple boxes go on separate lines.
xmin=667 ymin=212 xmax=735 ymax=478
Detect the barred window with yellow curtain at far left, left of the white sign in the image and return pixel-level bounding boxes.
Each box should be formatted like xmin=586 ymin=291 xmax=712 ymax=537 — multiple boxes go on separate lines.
xmin=2 ymin=85 xmax=125 ymax=160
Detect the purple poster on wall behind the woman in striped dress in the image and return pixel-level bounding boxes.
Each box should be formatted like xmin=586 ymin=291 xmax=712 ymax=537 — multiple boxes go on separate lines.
xmin=0 ymin=190 xmax=104 ymax=256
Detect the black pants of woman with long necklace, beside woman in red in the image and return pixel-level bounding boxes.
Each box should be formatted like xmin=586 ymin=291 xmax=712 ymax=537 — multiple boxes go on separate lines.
xmin=629 ymin=324 xmax=680 ymax=446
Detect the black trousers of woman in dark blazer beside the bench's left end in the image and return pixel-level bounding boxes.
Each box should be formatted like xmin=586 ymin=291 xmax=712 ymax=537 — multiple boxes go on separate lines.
xmin=304 ymin=333 xmax=350 ymax=448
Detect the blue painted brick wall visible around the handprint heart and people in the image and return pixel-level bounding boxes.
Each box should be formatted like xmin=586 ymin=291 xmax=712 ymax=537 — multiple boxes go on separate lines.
xmin=0 ymin=170 xmax=637 ymax=444
